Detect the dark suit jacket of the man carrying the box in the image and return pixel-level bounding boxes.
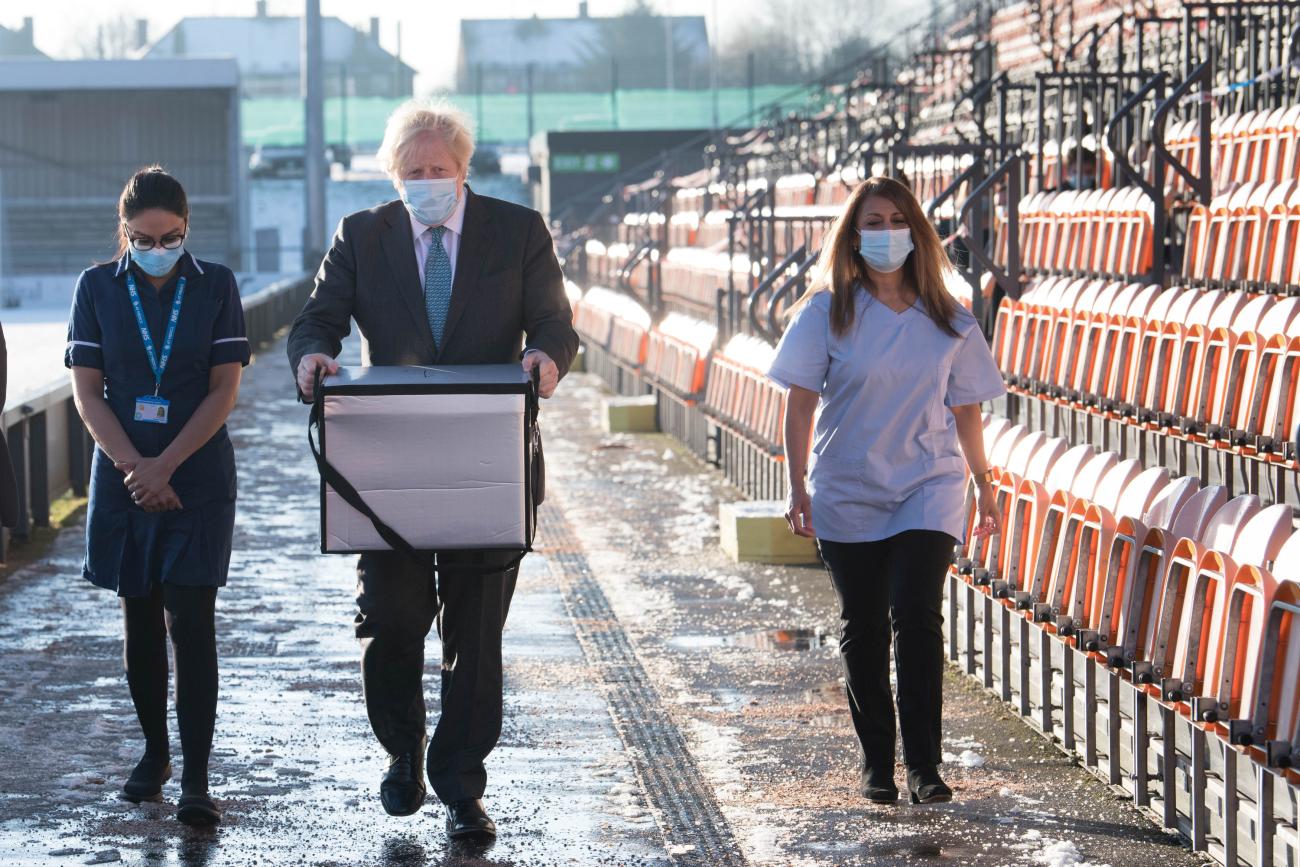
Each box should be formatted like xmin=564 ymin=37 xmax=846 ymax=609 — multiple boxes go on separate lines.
xmin=289 ymin=186 xmax=579 ymax=377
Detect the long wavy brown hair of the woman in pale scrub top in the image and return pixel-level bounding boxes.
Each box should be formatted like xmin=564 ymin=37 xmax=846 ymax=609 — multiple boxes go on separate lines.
xmin=790 ymin=175 xmax=958 ymax=337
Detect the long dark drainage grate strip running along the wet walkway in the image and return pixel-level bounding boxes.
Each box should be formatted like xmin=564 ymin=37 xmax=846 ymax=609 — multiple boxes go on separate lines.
xmin=538 ymin=504 xmax=745 ymax=867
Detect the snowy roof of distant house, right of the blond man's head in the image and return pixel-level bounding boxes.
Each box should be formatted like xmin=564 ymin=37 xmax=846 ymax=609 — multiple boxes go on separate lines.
xmin=460 ymin=16 xmax=709 ymax=68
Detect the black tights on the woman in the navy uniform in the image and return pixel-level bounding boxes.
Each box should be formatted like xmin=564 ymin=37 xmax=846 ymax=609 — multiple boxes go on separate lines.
xmin=122 ymin=584 xmax=217 ymax=792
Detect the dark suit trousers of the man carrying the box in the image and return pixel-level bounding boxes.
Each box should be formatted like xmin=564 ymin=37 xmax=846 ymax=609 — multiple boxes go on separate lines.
xmin=356 ymin=551 xmax=519 ymax=803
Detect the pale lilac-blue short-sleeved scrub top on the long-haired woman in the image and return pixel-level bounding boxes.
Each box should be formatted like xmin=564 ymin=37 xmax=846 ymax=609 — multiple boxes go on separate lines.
xmin=768 ymin=286 xmax=1005 ymax=542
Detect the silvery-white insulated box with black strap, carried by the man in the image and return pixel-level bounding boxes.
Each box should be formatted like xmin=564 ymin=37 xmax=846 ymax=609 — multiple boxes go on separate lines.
xmin=320 ymin=364 xmax=533 ymax=554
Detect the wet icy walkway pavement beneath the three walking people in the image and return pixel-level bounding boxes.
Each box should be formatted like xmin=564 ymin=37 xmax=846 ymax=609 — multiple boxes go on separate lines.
xmin=0 ymin=342 xmax=1204 ymax=867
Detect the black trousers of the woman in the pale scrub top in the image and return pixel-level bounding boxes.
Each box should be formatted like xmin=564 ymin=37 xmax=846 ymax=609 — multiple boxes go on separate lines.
xmin=818 ymin=530 xmax=956 ymax=775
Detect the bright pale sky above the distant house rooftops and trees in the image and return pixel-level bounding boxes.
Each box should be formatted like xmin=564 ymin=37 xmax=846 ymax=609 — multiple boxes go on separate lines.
xmin=0 ymin=0 xmax=930 ymax=90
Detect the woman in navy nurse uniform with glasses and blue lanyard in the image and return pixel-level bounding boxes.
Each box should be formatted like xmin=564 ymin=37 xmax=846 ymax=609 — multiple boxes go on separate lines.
xmin=65 ymin=166 xmax=250 ymax=824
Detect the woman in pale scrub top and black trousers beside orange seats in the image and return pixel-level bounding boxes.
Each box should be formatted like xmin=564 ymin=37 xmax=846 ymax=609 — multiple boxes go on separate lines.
xmin=768 ymin=177 xmax=1005 ymax=803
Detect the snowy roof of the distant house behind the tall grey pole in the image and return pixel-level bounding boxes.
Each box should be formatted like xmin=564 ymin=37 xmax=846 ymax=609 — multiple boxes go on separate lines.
xmin=143 ymin=16 xmax=415 ymax=77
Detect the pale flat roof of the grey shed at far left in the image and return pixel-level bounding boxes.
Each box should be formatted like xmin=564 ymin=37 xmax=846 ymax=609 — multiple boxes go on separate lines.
xmin=0 ymin=57 xmax=239 ymax=91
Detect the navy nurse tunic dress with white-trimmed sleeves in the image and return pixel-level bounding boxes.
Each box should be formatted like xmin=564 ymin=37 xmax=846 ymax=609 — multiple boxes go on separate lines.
xmin=64 ymin=252 xmax=250 ymax=597
